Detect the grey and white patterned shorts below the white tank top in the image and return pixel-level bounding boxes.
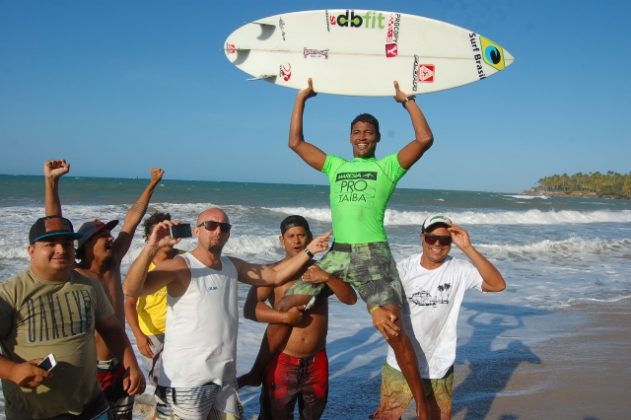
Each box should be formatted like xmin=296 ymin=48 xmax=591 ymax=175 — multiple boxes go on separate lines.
xmin=156 ymin=382 xmax=243 ymax=420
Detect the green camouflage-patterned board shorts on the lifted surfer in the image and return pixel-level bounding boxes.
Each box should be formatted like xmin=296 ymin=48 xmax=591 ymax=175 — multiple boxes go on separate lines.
xmin=286 ymin=242 xmax=403 ymax=308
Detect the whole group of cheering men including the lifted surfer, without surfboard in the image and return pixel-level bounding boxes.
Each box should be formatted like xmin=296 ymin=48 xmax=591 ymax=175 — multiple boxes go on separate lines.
xmin=0 ymin=80 xmax=506 ymax=420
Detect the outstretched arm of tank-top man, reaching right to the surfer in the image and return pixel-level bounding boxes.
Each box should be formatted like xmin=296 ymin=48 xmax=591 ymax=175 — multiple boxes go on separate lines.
xmin=230 ymin=232 xmax=331 ymax=286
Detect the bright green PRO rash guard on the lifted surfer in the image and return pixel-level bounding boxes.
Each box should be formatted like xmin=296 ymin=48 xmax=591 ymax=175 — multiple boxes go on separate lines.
xmin=322 ymin=154 xmax=407 ymax=244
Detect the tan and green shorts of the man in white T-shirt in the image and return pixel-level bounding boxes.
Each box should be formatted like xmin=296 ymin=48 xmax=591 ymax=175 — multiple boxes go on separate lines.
xmin=372 ymin=363 xmax=454 ymax=420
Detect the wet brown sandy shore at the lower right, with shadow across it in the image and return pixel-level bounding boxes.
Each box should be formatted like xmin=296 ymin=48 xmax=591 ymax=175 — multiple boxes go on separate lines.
xmin=130 ymin=299 xmax=631 ymax=420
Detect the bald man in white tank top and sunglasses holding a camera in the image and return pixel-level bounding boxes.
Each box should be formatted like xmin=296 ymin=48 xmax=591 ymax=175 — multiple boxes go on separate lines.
xmin=123 ymin=208 xmax=329 ymax=420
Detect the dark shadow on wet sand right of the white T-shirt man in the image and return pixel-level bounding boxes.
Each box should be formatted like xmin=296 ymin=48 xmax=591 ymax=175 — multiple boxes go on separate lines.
xmin=453 ymin=303 xmax=549 ymax=419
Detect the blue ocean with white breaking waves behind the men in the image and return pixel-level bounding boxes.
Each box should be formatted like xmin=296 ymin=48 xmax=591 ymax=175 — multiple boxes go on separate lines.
xmin=0 ymin=175 xmax=631 ymax=419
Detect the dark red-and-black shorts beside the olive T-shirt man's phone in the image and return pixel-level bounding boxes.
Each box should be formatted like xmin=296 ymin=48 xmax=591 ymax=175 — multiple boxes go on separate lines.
xmin=96 ymin=358 xmax=134 ymax=419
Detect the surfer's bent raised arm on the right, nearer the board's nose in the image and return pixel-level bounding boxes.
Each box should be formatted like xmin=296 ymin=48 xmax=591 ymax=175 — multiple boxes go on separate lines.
xmin=394 ymin=81 xmax=434 ymax=169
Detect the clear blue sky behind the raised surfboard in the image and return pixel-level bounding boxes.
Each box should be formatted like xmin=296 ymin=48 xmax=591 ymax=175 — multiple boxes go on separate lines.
xmin=0 ymin=0 xmax=631 ymax=192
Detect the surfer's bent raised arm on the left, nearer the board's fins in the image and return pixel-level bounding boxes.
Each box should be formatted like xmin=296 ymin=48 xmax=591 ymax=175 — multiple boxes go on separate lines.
xmin=289 ymin=79 xmax=326 ymax=171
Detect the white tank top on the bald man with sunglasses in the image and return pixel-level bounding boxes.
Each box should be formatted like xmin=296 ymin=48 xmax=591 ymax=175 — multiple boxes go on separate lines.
xmin=158 ymin=252 xmax=239 ymax=387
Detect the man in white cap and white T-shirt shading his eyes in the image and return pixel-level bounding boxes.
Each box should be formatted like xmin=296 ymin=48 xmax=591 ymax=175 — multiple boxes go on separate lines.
xmin=373 ymin=214 xmax=506 ymax=420
